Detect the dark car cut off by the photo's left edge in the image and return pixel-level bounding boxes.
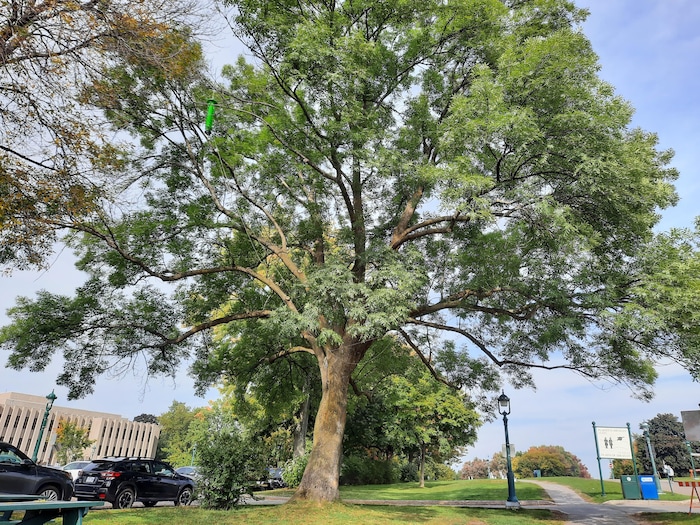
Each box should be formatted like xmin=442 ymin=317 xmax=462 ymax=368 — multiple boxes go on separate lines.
xmin=0 ymin=442 xmax=73 ymax=500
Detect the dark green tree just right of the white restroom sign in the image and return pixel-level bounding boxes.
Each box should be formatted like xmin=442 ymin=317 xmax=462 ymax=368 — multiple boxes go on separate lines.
xmin=634 ymin=414 xmax=691 ymax=476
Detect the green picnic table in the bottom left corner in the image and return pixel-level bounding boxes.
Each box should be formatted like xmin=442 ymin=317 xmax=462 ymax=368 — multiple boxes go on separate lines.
xmin=0 ymin=494 xmax=104 ymax=525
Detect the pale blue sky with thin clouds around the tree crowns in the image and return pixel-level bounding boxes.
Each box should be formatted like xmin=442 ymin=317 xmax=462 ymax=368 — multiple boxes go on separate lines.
xmin=0 ymin=0 xmax=700 ymax=477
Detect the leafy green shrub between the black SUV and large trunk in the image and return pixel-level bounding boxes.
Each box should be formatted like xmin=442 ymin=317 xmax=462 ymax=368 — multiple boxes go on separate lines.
xmin=197 ymin=430 xmax=265 ymax=509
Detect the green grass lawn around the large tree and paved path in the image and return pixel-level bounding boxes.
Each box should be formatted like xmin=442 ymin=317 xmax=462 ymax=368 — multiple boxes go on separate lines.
xmin=21 ymin=478 xmax=700 ymax=525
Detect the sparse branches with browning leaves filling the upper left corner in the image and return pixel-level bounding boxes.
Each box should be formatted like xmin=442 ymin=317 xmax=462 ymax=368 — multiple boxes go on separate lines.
xmin=0 ymin=0 xmax=208 ymax=269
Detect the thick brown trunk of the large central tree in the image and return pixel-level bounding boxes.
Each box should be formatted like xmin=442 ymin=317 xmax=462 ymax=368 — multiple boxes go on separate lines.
xmin=292 ymin=344 xmax=364 ymax=502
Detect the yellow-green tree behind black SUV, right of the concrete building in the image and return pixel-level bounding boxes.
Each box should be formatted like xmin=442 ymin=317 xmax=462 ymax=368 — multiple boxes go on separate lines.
xmin=156 ymin=401 xmax=196 ymax=467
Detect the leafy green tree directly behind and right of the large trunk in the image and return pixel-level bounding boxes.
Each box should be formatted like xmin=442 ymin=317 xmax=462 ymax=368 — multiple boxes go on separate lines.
xmin=341 ymin=338 xmax=480 ymax=485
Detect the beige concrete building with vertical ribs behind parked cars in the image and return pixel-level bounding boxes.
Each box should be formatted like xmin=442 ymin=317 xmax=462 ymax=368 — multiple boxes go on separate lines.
xmin=0 ymin=392 xmax=160 ymax=464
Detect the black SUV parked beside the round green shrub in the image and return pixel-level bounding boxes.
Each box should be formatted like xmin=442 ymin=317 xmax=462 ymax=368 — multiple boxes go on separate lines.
xmin=75 ymin=458 xmax=194 ymax=509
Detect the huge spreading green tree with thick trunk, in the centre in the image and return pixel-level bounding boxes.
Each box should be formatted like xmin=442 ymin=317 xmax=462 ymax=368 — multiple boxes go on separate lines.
xmin=0 ymin=0 xmax=697 ymax=501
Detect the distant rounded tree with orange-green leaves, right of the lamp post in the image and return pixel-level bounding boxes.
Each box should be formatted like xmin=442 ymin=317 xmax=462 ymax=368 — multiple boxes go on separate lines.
xmin=513 ymin=445 xmax=591 ymax=478
